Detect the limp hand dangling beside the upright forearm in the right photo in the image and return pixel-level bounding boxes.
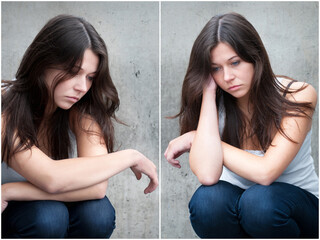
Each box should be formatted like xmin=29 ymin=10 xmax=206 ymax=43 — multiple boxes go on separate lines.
xmin=164 ymin=131 xmax=196 ymax=168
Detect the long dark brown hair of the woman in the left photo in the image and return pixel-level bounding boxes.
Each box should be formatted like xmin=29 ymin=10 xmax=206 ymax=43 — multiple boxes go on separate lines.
xmin=1 ymin=15 xmax=120 ymax=162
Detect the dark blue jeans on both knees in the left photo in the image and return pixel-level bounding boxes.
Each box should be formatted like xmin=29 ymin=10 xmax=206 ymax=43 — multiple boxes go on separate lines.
xmin=2 ymin=197 xmax=115 ymax=238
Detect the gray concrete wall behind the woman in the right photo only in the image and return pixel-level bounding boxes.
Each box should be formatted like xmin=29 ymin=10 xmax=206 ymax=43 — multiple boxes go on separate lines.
xmin=161 ymin=2 xmax=319 ymax=238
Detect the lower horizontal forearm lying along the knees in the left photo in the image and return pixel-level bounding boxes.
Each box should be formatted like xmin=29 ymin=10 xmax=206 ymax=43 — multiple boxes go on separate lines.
xmin=1 ymin=181 xmax=107 ymax=202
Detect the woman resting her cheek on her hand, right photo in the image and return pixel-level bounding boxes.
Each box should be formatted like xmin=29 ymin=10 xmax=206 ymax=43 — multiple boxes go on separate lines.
xmin=165 ymin=13 xmax=318 ymax=238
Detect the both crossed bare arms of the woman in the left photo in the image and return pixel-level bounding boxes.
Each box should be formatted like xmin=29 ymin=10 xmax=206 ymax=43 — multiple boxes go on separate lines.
xmin=2 ymin=112 xmax=158 ymax=206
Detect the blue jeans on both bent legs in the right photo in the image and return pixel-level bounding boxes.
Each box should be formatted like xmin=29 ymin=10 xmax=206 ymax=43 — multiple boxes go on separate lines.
xmin=189 ymin=181 xmax=319 ymax=238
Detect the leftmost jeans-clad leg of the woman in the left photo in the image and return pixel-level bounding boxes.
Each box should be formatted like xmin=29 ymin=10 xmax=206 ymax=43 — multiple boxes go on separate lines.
xmin=2 ymin=201 xmax=69 ymax=238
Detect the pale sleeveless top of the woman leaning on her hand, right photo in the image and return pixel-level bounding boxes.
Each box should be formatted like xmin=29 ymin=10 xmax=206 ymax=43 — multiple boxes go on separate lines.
xmin=219 ymin=79 xmax=319 ymax=198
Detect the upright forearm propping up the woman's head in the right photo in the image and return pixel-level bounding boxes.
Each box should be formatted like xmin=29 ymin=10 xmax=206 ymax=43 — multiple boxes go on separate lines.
xmin=189 ymin=93 xmax=222 ymax=185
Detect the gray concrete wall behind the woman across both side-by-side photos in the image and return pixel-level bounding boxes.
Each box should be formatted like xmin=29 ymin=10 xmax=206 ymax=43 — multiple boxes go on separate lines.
xmin=1 ymin=2 xmax=319 ymax=238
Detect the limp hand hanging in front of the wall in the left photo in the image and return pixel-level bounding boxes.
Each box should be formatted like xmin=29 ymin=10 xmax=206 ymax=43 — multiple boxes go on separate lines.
xmin=131 ymin=151 xmax=159 ymax=194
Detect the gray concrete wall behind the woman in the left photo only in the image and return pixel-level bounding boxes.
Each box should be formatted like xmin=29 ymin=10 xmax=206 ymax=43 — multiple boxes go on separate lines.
xmin=1 ymin=2 xmax=159 ymax=238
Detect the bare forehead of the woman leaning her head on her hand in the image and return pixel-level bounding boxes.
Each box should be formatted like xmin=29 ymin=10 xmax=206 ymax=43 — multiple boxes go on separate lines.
xmin=210 ymin=42 xmax=238 ymax=64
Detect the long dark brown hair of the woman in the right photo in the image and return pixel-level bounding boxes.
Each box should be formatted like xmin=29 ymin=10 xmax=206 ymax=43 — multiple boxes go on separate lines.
xmin=176 ymin=13 xmax=312 ymax=151
